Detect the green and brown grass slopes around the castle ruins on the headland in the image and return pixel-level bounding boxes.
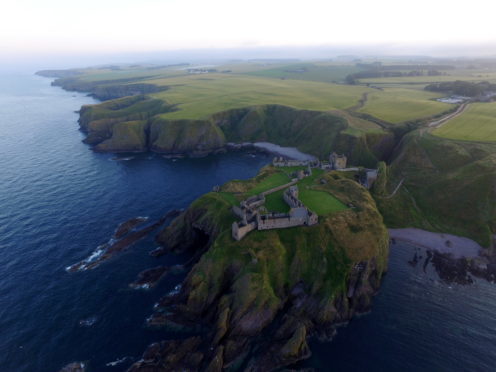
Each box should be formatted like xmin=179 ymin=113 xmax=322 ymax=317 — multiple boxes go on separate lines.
xmin=159 ymin=167 xmax=388 ymax=328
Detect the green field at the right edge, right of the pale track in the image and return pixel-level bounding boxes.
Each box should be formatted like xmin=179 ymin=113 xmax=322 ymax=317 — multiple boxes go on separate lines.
xmin=433 ymin=102 xmax=496 ymax=141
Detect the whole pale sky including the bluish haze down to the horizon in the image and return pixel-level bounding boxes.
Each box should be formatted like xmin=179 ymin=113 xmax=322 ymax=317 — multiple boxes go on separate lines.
xmin=0 ymin=0 xmax=496 ymax=69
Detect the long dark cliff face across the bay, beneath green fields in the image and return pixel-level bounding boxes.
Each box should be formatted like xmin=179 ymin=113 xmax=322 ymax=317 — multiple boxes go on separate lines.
xmin=79 ymin=95 xmax=394 ymax=162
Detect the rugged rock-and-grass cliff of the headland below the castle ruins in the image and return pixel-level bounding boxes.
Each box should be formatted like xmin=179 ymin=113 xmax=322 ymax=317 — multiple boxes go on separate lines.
xmin=130 ymin=174 xmax=388 ymax=371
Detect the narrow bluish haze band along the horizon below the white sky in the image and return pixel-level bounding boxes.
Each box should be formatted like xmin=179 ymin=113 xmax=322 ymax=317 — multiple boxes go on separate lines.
xmin=0 ymin=43 xmax=496 ymax=72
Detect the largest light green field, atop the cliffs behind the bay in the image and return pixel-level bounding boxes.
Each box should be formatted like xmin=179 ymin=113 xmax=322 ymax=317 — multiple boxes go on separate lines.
xmin=144 ymin=74 xmax=371 ymax=119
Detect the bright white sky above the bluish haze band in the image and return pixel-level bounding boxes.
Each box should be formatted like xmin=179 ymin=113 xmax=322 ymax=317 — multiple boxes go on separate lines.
xmin=0 ymin=0 xmax=496 ymax=64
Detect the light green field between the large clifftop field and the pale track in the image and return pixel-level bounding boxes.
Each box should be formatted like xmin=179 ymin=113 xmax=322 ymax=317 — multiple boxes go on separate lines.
xmin=359 ymin=88 xmax=451 ymax=124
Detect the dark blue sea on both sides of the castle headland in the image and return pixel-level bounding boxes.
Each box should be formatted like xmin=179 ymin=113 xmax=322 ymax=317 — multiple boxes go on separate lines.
xmin=0 ymin=74 xmax=496 ymax=372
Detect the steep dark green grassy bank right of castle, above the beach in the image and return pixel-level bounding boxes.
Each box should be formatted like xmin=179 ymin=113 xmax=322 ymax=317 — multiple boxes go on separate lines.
xmin=374 ymin=130 xmax=496 ymax=247
